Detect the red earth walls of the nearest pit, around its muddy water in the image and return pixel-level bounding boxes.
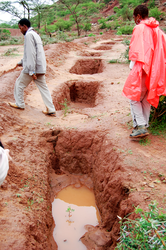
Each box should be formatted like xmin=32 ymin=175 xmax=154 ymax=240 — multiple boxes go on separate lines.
xmin=44 ymin=129 xmax=133 ymax=249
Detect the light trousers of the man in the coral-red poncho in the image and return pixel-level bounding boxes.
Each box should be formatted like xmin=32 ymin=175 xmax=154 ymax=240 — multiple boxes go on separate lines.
xmin=130 ymin=71 xmax=151 ymax=127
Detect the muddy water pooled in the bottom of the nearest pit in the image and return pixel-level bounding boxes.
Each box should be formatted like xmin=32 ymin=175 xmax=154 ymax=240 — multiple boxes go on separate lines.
xmin=52 ymin=186 xmax=100 ymax=250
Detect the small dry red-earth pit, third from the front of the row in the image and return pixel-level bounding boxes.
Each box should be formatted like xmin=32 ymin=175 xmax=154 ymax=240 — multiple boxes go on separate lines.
xmin=69 ymin=59 xmax=104 ymax=75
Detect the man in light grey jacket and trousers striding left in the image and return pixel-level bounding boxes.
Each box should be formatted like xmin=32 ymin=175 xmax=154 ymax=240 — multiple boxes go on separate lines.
xmin=9 ymin=18 xmax=56 ymax=115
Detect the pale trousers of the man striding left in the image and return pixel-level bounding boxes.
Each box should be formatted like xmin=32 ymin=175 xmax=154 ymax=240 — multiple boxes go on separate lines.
xmin=14 ymin=71 xmax=55 ymax=113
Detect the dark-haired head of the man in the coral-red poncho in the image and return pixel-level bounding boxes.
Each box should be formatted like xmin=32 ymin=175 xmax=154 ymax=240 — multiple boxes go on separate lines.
xmin=133 ymin=5 xmax=149 ymax=24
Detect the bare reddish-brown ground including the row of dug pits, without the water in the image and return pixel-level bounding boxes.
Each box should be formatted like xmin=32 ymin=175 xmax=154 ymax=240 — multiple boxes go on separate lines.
xmin=0 ymin=32 xmax=166 ymax=250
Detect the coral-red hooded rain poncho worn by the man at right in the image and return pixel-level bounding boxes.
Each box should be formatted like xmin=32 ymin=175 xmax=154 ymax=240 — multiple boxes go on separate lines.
xmin=123 ymin=17 xmax=166 ymax=108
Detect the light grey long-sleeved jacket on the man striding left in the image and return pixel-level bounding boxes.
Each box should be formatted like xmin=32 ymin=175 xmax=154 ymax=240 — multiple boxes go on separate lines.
xmin=18 ymin=27 xmax=46 ymax=75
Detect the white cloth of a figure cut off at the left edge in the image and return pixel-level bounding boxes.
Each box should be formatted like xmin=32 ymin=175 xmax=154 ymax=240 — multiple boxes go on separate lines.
xmin=0 ymin=147 xmax=9 ymax=186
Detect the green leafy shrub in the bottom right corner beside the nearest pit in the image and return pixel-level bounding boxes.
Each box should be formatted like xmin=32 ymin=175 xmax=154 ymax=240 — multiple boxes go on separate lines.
xmin=116 ymin=202 xmax=166 ymax=250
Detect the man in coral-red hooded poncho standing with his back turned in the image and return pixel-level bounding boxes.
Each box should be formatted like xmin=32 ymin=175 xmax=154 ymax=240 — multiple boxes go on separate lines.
xmin=123 ymin=5 xmax=166 ymax=138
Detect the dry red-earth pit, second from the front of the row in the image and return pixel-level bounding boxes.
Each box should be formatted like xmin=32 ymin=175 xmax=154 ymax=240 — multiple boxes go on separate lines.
xmin=53 ymin=80 xmax=101 ymax=110
